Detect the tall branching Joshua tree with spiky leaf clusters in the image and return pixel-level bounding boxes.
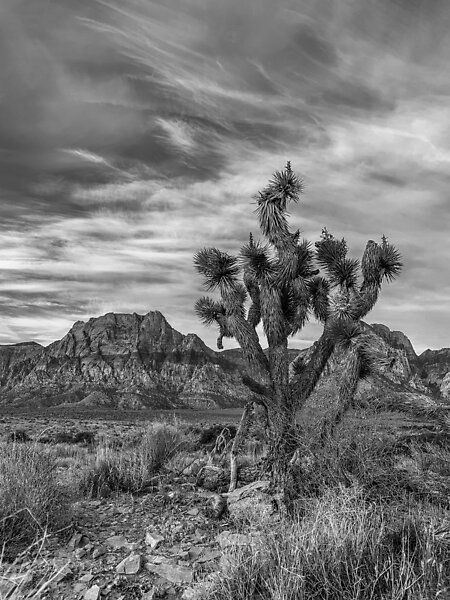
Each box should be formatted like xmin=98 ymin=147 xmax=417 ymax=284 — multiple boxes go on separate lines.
xmin=194 ymin=163 xmax=402 ymax=496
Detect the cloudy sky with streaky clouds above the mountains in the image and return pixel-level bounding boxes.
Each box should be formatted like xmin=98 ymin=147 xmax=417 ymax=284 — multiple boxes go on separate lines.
xmin=0 ymin=0 xmax=450 ymax=352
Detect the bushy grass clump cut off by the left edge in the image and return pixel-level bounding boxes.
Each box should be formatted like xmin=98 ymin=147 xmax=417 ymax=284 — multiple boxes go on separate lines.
xmin=0 ymin=444 xmax=70 ymax=548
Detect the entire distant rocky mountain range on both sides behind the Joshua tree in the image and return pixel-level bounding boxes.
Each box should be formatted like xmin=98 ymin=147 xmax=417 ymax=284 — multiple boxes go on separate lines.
xmin=0 ymin=311 xmax=450 ymax=409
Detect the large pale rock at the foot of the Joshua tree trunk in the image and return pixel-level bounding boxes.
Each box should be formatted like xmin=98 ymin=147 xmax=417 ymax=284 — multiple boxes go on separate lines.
xmin=227 ymin=481 xmax=274 ymax=520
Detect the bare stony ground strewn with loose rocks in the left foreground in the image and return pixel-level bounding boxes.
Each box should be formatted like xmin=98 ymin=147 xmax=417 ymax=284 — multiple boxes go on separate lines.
xmin=0 ymin=477 xmax=258 ymax=600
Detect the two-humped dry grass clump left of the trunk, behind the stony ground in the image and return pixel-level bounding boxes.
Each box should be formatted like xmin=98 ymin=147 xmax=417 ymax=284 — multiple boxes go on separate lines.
xmin=80 ymin=423 xmax=188 ymax=497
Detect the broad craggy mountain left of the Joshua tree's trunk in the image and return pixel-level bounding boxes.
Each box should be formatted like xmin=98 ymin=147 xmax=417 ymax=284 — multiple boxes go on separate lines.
xmin=0 ymin=312 xmax=248 ymax=409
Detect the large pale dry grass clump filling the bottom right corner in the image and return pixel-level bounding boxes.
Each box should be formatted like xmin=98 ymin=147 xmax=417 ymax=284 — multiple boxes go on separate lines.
xmin=207 ymin=487 xmax=450 ymax=600
